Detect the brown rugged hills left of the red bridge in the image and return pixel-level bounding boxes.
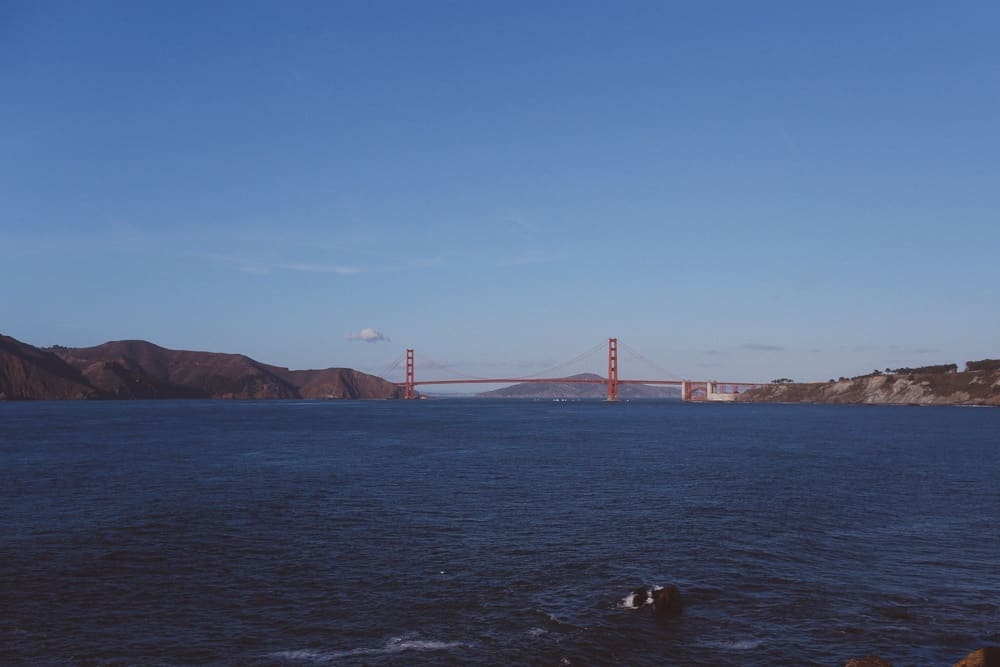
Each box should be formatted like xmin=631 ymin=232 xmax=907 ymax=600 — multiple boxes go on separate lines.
xmin=0 ymin=336 xmax=402 ymax=400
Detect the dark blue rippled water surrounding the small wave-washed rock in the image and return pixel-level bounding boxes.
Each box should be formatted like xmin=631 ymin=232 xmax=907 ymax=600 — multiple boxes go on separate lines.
xmin=0 ymin=400 xmax=1000 ymax=665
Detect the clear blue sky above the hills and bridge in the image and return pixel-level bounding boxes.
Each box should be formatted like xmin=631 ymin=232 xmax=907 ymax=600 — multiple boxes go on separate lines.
xmin=0 ymin=0 xmax=1000 ymax=380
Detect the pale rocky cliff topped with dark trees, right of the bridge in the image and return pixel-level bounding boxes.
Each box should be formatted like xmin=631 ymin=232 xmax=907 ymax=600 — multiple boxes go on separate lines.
xmin=740 ymin=359 xmax=1000 ymax=406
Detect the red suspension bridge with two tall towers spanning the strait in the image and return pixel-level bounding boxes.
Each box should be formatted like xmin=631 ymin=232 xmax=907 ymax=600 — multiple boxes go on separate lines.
xmin=389 ymin=338 xmax=765 ymax=401
